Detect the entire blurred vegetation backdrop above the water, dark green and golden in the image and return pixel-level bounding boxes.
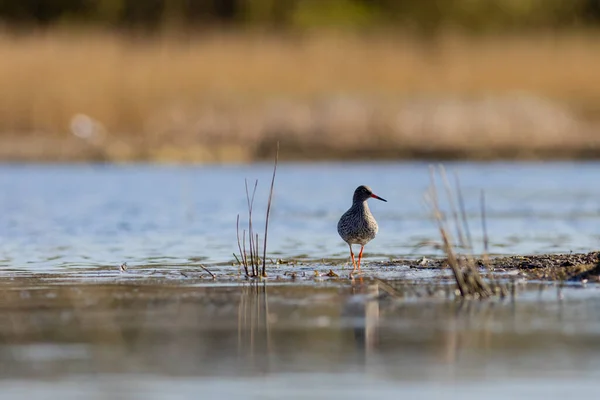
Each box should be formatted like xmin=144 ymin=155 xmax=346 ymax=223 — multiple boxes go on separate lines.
xmin=0 ymin=0 xmax=600 ymax=162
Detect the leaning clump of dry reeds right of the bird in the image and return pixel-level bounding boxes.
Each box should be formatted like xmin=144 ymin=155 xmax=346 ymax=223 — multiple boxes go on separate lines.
xmin=427 ymin=166 xmax=507 ymax=298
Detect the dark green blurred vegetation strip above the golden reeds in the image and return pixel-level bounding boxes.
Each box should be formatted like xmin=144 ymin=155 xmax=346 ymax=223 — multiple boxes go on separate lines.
xmin=0 ymin=0 xmax=600 ymax=34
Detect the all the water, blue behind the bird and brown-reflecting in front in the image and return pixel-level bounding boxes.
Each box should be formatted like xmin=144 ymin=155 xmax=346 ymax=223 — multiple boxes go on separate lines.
xmin=0 ymin=163 xmax=600 ymax=400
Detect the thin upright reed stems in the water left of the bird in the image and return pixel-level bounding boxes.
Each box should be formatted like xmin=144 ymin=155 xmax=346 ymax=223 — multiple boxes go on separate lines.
xmin=234 ymin=143 xmax=279 ymax=278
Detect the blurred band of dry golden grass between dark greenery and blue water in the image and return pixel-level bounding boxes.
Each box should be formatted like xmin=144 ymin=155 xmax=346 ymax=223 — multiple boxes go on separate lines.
xmin=0 ymin=30 xmax=600 ymax=162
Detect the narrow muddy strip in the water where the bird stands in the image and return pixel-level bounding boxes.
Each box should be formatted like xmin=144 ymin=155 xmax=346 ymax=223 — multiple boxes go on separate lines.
xmin=3 ymin=251 xmax=600 ymax=287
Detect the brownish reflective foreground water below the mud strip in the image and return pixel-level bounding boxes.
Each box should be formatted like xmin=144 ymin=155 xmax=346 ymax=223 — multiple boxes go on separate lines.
xmin=0 ymin=276 xmax=600 ymax=399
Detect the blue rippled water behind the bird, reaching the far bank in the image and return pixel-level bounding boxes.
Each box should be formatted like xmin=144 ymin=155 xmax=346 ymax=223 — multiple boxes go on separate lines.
xmin=0 ymin=163 xmax=600 ymax=272
